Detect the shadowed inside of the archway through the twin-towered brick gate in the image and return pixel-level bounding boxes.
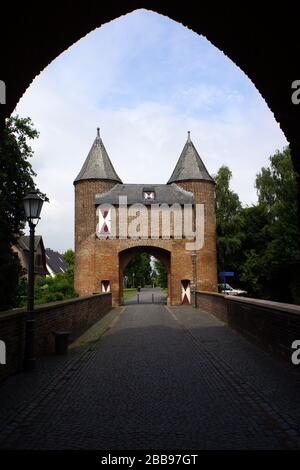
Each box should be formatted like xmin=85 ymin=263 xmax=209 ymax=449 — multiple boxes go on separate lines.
xmin=119 ymin=244 xmax=172 ymax=305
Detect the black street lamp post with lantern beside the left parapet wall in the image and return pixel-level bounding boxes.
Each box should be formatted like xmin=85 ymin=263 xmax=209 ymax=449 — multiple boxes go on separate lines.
xmin=23 ymin=191 xmax=44 ymax=370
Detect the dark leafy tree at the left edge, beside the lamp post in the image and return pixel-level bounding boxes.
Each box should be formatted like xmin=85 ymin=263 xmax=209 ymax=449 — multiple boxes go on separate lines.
xmin=0 ymin=115 xmax=44 ymax=310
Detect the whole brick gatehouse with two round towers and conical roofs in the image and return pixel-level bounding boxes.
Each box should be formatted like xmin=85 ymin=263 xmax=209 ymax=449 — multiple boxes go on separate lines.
xmin=74 ymin=129 xmax=217 ymax=305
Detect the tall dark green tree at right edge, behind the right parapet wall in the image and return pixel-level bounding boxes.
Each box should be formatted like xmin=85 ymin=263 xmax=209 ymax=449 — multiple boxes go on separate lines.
xmin=241 ymin=148 xmax=300 ymax=303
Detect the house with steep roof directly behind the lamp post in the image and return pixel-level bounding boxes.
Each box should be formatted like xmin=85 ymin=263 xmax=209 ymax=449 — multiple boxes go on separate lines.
xmin=12 ymin=235 xmax=48 ymax=276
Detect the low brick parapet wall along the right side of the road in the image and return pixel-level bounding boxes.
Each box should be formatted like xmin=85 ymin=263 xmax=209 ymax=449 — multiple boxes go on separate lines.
xmin=197 ymin=292 xmax=300 ymax=369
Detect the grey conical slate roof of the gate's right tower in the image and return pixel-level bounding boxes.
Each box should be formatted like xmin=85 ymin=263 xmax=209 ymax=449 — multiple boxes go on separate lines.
xmin=168 ymin=132 xmax=213 ymax=184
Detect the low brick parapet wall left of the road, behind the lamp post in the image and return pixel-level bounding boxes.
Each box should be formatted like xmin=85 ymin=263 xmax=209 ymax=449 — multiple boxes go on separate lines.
xmin=0 ymin=293 xmax=112 ymax=380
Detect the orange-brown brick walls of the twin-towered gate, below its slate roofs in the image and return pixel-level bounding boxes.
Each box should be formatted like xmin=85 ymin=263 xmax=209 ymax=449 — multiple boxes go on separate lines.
xmin=75 ymin=180 xmax=217 ymax=305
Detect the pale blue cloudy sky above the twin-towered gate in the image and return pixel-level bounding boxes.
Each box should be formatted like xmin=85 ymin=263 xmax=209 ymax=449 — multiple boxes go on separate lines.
xmin=16 ymin=10 xmax=287 ymax=251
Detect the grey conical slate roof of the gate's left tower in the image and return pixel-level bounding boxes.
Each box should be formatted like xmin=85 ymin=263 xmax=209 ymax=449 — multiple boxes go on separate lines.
xmin=74 ymin=127 xmax=122 ymax=183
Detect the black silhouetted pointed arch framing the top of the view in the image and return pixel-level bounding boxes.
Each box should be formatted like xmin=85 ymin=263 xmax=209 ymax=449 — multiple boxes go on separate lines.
xmin=0 ymin=0 xmax=300 ymax=209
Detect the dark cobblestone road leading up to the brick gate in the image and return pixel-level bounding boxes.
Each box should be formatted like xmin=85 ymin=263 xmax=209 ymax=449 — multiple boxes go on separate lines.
xmin=0 ymin=305 xmax=300 ymax=450
